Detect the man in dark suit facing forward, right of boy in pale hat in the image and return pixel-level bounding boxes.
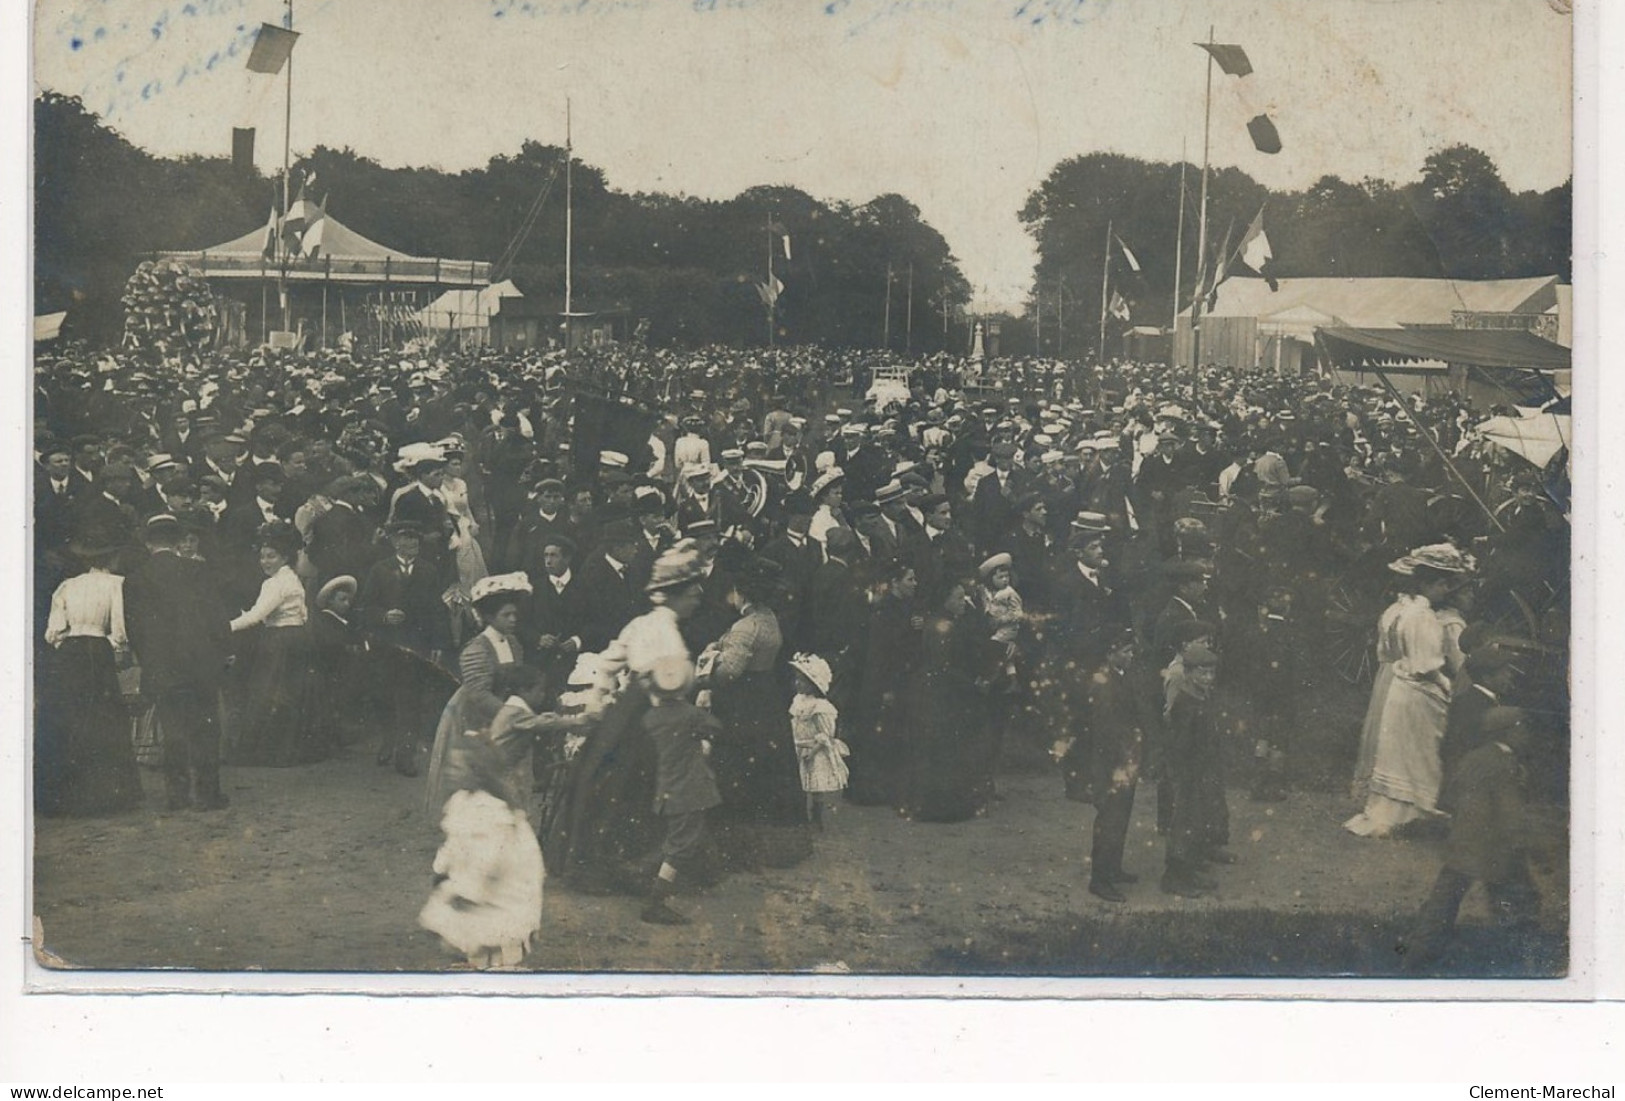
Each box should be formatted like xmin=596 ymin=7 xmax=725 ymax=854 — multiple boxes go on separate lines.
xmin=356 ymin=521 xmax=452 ymax=776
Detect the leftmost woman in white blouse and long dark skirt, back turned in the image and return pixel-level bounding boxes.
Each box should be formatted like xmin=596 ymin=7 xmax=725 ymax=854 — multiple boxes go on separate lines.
xmin=34 ymin=541 xmax=141 ymax=817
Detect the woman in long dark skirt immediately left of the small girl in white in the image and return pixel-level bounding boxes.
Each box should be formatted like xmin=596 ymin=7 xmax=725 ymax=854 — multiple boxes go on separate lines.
xmin=699 ymin=559 xmax=813 ymax=869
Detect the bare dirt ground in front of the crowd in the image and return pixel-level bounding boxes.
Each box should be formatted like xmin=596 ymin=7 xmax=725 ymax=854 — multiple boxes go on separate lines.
xmin=33 ymin=747 xmax=1568 ymax=974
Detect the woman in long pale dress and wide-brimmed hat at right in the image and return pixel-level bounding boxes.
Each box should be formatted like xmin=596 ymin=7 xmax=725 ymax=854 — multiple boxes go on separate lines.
xmin=1344 ymin=542 xmax=1477 ymax=836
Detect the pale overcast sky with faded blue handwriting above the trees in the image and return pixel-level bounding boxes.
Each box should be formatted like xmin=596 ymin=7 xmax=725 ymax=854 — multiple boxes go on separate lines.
xmin=34 ymin=0 xmax=1571 ymax=305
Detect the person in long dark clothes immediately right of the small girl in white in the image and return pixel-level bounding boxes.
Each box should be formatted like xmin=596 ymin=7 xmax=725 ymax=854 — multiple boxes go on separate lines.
xmin=842 ymin=559 xmax=925 ymax=807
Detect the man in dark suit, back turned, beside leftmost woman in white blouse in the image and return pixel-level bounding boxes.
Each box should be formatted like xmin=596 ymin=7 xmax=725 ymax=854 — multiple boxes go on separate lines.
xmin=124 ymin=516 xmax=231 ymax=810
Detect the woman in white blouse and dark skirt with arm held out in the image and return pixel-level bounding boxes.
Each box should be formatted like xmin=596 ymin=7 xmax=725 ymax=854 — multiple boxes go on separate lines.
xmin=231 ymin=523 xmax=323 ymax=766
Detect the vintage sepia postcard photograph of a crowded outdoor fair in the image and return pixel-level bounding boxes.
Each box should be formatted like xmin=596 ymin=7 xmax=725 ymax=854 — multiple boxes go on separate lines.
xmin=23 ymin=0 xmax=1597 ymax=997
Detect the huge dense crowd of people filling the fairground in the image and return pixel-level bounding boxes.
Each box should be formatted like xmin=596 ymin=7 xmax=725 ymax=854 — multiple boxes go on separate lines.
xmin=34 ymin=336 xmax=1568 ymax=965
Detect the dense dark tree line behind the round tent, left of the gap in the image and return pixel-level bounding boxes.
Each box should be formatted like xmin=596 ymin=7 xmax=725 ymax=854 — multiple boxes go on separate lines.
xmin=34 ymin=93 xmax=970 ymax=349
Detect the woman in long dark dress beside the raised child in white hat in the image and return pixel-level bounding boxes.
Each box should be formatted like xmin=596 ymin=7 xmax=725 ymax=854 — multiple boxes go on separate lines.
xmin=902 ymin=563 xmax=1003 ymax=822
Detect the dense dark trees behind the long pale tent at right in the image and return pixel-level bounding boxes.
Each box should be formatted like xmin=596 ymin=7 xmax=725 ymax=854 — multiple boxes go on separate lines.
xmin=1021 ymin=146 xmax=1573 ymax=351
